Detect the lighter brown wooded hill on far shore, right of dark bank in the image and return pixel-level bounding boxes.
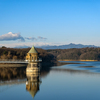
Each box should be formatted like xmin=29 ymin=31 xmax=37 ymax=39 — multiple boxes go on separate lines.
xmin=47 ymin=48 xmax=100 ymax=60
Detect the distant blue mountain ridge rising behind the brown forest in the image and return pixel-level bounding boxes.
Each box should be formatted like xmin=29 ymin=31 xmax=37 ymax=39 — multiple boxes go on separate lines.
xmin=15 ymin=43 xmax=98 ymax=50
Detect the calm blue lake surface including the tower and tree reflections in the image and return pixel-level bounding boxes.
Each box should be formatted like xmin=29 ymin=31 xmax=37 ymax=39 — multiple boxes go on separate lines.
xmin=0 ymin=61 xmax=100 ymax=100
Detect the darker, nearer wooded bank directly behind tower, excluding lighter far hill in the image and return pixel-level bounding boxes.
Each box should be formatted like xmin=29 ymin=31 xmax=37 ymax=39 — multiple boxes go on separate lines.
xmin=0 ymin=48 xmax=56 ymax=62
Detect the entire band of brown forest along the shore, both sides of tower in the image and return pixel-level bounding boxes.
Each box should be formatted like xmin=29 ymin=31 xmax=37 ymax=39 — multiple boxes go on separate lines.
xmin=0 ymin=47 xmax=100 ymax=62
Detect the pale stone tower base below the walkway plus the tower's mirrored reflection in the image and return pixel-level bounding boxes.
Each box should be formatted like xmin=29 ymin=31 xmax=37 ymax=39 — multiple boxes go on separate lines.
xmin=26 ymin=63 xmax=41 ymax=98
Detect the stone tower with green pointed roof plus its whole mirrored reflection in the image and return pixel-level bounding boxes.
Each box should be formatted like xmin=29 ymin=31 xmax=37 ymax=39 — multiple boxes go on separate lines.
xmin=26 ymin=46 xmax=41 ymax=98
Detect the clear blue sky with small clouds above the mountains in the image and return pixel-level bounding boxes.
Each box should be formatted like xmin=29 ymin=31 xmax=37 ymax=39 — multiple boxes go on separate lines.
xmin=0 ymin=0 xmax=100 ymax=46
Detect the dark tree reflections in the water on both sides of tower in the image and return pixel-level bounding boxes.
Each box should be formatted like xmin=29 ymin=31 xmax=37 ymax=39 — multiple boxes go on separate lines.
xmin=0 ymin=63 xmax=67 ymax=81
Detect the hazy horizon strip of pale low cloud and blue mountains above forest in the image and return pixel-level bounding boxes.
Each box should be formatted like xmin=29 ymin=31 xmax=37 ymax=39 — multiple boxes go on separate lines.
xmin=0 ymin=43 xmax=99 ymax=49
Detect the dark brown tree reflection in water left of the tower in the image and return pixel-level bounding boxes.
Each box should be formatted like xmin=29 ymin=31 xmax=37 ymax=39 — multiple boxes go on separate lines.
xmin=0 ymin=67 xmax=26 ymax=80
